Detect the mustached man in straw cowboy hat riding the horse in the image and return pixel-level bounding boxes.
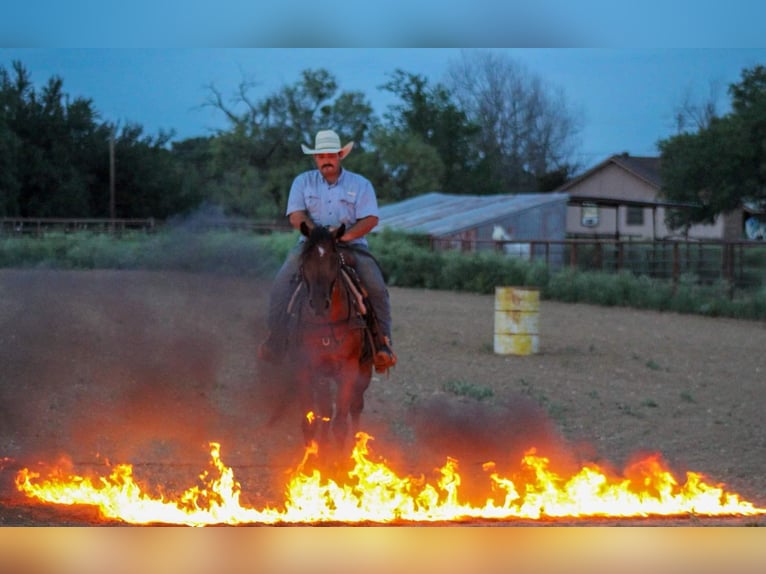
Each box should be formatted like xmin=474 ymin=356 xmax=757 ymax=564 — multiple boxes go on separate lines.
xmin=258 ymin=130 xmax=396 ymax=372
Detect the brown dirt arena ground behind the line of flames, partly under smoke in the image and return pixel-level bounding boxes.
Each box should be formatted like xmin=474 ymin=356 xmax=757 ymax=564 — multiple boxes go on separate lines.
xmin=0 ymin=270 xmax=766 ymax=525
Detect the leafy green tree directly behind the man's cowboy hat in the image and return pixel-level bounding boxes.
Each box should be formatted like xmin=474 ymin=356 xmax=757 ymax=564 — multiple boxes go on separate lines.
xmin=205 ymin=70 xmax=375 ymax=217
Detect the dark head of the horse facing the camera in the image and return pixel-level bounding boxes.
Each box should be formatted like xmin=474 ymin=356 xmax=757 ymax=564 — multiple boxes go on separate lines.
xmin=301 ymin=222 xmax=346 ymax=317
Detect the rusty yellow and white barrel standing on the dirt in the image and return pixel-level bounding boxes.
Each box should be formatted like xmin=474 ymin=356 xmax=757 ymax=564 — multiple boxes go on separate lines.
xmin=495 ymin=287 xmax=540 ymax=355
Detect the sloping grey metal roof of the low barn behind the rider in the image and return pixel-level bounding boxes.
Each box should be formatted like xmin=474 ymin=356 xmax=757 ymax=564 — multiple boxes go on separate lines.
xmin=376 ymin=192 xmax=569 ymax=237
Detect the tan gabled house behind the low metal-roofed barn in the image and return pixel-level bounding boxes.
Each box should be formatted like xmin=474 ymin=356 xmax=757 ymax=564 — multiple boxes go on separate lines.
xmin=556 ymin=154 xmax=743 ymax=240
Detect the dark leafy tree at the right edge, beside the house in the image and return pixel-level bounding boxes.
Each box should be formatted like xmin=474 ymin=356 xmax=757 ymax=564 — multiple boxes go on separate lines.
xmin=658 ymin=66 xmax=766 ymax=228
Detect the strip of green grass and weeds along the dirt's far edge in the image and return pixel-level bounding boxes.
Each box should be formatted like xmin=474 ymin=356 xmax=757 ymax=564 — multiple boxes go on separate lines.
xmin=6 ymin=229 xmax=766 ymax=320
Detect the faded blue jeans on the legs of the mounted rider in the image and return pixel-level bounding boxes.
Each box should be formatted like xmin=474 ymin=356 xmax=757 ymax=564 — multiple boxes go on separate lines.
xmin=268 ymin=244 xmax=393 ymax=340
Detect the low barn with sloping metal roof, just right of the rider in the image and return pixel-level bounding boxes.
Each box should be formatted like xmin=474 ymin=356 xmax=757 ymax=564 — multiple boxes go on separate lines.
xmin=375 ymin=192 xmax=569 ymax=257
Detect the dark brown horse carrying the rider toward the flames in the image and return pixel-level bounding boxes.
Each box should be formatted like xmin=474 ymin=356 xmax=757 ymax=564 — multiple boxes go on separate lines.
xmin=289 ymin=223 xmax=372 ymax=447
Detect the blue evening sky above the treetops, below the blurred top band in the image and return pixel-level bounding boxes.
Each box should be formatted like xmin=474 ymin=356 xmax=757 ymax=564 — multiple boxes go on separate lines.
xmin=0 ymin=48 xmax=766 ymax=168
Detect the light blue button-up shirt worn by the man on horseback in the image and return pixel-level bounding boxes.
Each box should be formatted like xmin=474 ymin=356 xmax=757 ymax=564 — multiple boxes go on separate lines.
xmin=285 ymin=169 xmax=378 ymax=246
